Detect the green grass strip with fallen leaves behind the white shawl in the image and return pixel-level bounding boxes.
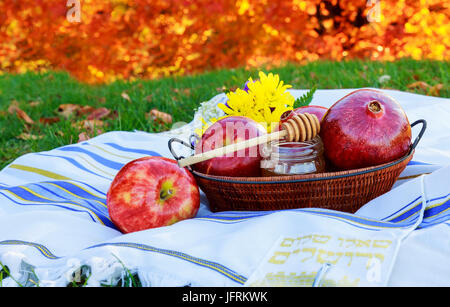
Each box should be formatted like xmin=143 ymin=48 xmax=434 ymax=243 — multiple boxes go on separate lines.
xmin=0 ymin=59 xmax=450 ymax=169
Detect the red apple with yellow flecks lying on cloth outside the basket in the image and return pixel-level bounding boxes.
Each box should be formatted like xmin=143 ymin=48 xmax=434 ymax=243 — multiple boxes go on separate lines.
xmin=106 ymin=157 xmax=200 ymax=233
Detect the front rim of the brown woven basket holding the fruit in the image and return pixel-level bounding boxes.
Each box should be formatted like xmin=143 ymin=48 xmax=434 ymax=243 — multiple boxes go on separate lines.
xmin=191 ymin=149 xmax=415 ymax=184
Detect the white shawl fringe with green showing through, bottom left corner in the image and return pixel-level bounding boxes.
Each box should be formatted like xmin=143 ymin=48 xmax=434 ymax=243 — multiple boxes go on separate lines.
xmin=0 ymin=251 xmax=192 ymax=287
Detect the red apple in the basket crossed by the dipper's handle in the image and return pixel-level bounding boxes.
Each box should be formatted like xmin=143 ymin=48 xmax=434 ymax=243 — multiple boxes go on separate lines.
xmin=193 ymin=116 xmax=266 ymax=177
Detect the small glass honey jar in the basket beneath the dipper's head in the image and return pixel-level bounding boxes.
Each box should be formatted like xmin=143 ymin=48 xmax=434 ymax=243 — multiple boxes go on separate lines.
xmin=261 ymin=136 xmax=325 ymax=176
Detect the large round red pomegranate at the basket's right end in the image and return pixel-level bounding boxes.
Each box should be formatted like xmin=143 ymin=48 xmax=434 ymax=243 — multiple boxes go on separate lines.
xmin=320 ymin=89 xmax=411 ymax=170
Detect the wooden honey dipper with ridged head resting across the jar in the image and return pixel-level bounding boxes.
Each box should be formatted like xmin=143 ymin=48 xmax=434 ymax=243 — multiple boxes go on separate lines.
xmin=178 ymin=113 xmax=320 ymax=167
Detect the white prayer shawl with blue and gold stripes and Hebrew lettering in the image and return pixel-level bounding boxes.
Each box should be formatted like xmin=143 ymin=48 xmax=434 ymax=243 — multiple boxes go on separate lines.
xmin=0 ymin=89 xmax=450 ymax=286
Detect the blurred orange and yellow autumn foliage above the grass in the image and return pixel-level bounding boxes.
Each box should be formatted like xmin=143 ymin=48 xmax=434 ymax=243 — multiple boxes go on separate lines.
xmin=0 ymin=0 xmax=450 ymax=83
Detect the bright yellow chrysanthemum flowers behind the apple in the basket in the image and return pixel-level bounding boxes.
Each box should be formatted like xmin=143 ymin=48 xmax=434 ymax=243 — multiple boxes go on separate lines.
xmin=218 ymin=72 xmax=295 ymax=132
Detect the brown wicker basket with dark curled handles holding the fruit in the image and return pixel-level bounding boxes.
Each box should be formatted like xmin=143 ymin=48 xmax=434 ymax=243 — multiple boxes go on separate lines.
xmin=169 ymin=120 xmax=426 ymax=213
